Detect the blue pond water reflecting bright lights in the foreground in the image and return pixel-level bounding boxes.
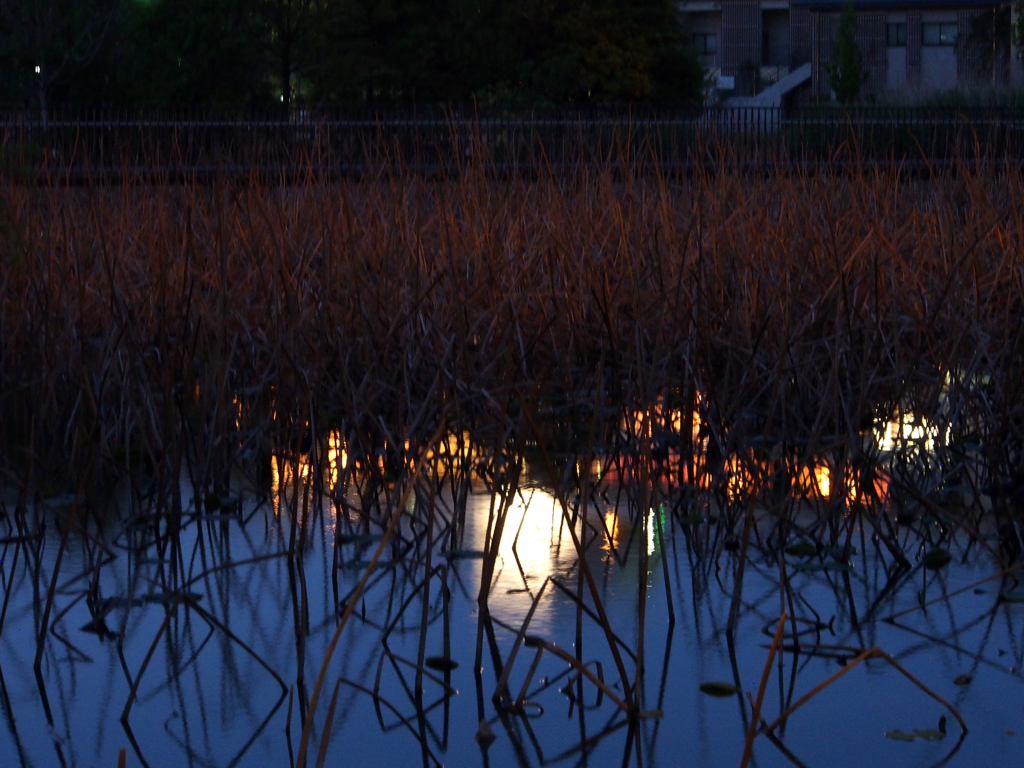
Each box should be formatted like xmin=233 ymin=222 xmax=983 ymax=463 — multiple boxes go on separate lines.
xmin=0 ymin=429 xmax=1024 ymax=767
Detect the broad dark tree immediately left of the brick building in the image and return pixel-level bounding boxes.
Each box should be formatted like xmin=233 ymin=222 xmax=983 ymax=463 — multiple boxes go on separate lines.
xmin=324 ymin=0 xmax=703 ymax=105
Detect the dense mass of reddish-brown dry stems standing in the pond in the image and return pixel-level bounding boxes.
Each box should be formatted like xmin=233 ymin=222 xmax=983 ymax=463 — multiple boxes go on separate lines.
xmin=0 ymin=147 xmax=1024 ymax=764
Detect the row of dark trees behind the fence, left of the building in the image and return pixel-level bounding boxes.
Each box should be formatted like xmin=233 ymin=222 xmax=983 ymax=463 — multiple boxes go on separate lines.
xmin=0 ymin=0 xmax=703 ymax=105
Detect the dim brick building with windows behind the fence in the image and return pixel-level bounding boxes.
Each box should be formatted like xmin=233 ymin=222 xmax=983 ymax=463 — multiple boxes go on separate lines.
xmin=679 ymin=0 xmax=1012 ymax=98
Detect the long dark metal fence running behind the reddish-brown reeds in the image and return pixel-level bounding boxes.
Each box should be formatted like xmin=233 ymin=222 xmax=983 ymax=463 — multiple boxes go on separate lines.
xmin=0 ymin=106 xmax=1024 ymax=180
